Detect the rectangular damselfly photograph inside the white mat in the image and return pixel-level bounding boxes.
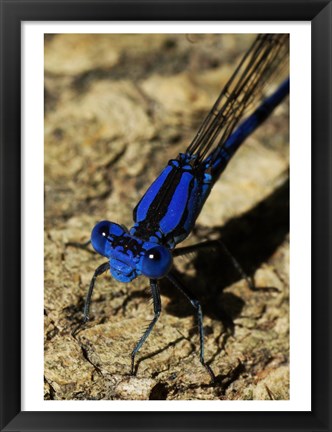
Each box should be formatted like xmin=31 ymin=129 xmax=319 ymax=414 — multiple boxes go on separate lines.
xmin=41 ymin=33 xmax=290 ymax=401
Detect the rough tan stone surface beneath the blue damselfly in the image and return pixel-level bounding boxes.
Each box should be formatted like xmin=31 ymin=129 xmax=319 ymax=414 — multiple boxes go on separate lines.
xmin=45 ymin=34 xmax=289 ymax=400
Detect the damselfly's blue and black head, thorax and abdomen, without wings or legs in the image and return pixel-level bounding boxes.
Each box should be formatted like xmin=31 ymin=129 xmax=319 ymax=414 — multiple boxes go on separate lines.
xmin=91 ymin=79 xmax=289 ymax=282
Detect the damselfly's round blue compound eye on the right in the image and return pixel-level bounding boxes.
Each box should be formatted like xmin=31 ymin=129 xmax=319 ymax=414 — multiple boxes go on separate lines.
xmin=142 ymin=246 xmax=173 ymax=279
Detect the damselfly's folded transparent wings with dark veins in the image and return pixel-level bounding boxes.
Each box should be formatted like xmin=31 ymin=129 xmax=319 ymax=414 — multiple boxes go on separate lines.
xmin=186 ymin=34 xmax=289 ymax=163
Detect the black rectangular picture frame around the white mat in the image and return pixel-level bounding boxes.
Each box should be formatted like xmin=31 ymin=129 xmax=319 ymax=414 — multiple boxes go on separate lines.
xmin=0 ymin=0 xmax=332 ymax=431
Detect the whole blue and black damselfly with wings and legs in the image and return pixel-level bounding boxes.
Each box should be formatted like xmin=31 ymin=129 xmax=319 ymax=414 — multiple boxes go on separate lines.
xmin=74 ymin=35 xmax=289 ymax=380
